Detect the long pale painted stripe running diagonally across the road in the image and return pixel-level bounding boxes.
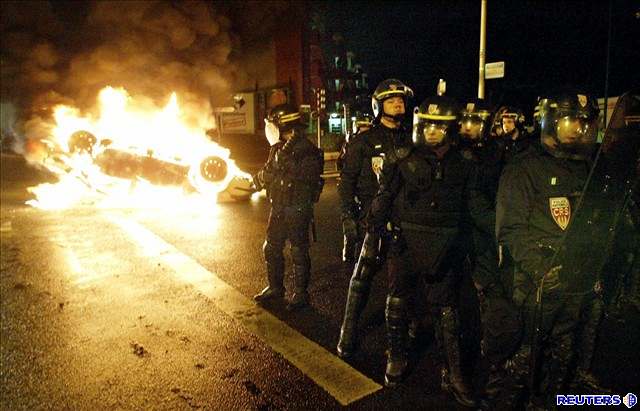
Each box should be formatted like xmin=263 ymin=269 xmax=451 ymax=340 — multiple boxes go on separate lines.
xmin=111 ymin=216 xmax=382 ymax=405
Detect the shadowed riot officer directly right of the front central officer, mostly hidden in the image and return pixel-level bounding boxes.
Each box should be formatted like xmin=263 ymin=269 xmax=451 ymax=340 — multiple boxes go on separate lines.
xmin=459 ymin=99 xmax=521 ymax=398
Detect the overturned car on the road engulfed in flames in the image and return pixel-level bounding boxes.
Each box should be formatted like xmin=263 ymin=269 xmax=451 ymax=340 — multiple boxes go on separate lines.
xmin=30 ymin=87 xmax=254 ymax=208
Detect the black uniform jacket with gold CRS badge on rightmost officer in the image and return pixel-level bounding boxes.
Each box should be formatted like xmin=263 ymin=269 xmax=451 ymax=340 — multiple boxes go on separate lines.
xmin=496 ymin=143 xmax=590 ymax=280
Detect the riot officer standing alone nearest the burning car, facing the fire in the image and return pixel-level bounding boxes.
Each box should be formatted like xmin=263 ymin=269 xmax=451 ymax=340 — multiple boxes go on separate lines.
xmin=253 ymin=104 xmax=324 ymax=310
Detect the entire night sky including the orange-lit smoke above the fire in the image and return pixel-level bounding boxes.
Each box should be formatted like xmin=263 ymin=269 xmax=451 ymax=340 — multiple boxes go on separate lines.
xmin=0 ymin=0 xmax=640 ymax=143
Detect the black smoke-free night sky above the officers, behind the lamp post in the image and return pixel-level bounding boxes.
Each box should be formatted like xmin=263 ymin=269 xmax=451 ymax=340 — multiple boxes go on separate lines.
xmin=326 ymin=0 xmax=640 ymax=113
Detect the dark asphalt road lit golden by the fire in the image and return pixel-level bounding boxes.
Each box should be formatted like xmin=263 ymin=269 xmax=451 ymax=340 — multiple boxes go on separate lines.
xmin=0 ymin=155 xmax=640 ymax=410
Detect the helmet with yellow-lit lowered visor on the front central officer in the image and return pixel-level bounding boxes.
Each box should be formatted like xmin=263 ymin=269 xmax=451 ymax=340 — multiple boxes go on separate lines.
xmin=412 ymin=96 xmax=459 ymax=147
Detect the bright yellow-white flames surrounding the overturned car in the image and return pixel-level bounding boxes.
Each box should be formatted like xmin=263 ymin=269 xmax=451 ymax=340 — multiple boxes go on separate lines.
xmin=27 ymin=87 xmax=250 ymax=210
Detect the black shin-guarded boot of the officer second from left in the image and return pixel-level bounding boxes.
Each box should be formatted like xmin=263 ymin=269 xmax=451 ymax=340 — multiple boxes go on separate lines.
xmin=336 ymin=277 xmax=370 ymax=358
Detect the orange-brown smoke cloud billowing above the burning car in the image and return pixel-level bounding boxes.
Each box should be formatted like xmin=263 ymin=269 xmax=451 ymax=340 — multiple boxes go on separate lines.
xmin=1 ymin=1 xmax=289 ymax=148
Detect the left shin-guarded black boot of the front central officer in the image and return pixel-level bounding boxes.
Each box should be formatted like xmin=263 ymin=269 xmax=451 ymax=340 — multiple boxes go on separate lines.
xmin=384 ymin=296 xmax=409 ymax=387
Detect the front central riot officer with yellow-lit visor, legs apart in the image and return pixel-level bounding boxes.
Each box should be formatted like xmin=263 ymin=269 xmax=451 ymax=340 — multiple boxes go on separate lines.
xmin=367 ymin=96 xmax=488 ymax=406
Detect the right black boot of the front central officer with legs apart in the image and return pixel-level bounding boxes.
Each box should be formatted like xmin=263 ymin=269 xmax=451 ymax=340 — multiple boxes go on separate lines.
xmin=440 ymin=307 xmax=478 ymax=407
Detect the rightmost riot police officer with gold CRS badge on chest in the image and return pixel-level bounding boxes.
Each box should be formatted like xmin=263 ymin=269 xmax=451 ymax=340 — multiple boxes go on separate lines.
xmin=496 ymin=92 xmax=602 ymax=407
